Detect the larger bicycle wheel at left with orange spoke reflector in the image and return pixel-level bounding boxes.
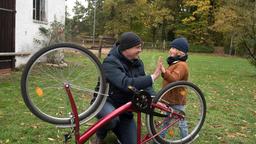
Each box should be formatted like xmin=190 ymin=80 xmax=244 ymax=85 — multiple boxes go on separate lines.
xmin=21 ymin=43 xmax=107 ymax=126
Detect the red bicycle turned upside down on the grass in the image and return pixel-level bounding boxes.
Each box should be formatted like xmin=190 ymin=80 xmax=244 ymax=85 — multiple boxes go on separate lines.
xmin=21 ymin=43 xmax=206 ymax=144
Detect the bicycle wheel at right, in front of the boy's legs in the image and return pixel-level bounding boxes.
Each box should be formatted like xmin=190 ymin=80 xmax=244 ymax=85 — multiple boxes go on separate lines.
xmin=146 ymin=81 xmax=206 ymax=144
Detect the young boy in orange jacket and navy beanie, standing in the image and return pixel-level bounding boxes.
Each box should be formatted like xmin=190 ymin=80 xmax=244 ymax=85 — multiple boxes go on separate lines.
xmin=161 ymin=38 xmax=189 ymax=138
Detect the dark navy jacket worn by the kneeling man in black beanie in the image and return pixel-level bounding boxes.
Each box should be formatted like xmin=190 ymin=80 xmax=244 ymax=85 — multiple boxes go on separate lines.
xmin=103 ymin=44 xmax=154 ymax=107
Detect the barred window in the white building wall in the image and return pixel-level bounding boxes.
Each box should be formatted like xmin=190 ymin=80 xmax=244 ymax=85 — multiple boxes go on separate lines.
xmin=33 ymin=0 xmax=47 ymax=21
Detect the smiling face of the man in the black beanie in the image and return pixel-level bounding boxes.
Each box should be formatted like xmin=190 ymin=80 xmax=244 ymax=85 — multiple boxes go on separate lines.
xmin=122 ymin=44 xmax=142 ymax=60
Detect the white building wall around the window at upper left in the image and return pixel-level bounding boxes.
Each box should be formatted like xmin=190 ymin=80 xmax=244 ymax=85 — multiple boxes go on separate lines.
xmin=15 ymin=0 xmax=65 ymax=67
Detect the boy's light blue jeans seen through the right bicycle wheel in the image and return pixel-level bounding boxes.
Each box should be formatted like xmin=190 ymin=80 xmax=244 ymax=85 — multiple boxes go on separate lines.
xmin=160 ymin=105 xmax=188 ymax=138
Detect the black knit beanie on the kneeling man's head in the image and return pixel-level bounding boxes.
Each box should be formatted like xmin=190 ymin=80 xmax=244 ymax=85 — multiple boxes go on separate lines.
xmin=118 ymin=32 xmax=141 ymax=51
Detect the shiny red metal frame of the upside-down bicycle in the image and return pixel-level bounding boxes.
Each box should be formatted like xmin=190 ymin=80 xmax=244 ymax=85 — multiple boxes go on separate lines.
xmin=65 ymin=84 xmax=183 ymax=144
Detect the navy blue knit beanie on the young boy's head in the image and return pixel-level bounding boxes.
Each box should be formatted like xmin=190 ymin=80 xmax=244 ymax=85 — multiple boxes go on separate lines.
xmin=170 ymin=37 xmax=188 ymax=53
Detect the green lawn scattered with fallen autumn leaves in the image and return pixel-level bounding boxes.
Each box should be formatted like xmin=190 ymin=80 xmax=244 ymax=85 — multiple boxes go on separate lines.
xmin=0 ymin=51 xmax=256 ymax=144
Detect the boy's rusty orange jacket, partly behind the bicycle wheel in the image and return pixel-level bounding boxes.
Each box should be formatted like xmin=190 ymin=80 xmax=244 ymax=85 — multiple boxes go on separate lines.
xmin=162 ymin=61 xmax=189 ymax=105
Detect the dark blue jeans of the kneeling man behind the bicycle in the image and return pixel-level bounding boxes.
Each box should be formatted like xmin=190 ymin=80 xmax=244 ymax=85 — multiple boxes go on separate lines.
xmin=96 ymin=102 xmax=137 ymax=144
